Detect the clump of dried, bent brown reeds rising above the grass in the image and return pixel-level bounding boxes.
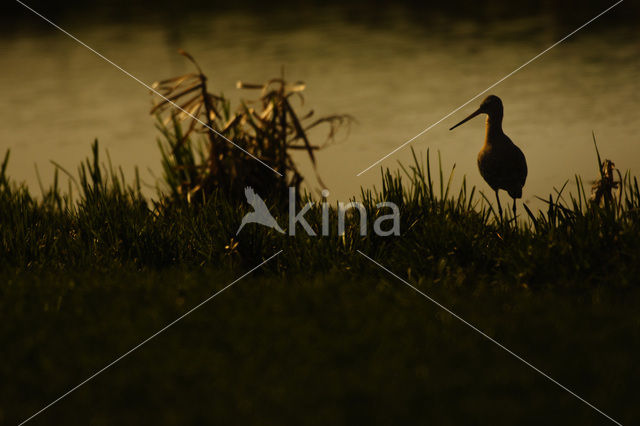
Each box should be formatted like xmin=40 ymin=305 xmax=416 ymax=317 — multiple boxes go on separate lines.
xmin=151 ymin=50 xmax=352 ymax=202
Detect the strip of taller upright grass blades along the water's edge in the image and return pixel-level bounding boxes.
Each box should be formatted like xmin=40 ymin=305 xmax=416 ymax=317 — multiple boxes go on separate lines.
xmin=0 ymin=141 xmax=640 ymax=288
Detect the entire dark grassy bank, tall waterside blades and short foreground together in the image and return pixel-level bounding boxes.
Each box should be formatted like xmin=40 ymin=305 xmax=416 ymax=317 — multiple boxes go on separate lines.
xmin=0 ymin=141 xmax=640 ymax=425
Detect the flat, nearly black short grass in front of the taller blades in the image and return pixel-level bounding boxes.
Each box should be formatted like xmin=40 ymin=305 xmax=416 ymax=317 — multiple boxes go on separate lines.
xmin=0 ymin=269 xmax=640 ymax=425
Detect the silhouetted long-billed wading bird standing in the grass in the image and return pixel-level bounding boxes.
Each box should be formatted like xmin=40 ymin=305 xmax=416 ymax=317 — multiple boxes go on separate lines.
xmin=451 ymin=95 xmax=527 ymax=217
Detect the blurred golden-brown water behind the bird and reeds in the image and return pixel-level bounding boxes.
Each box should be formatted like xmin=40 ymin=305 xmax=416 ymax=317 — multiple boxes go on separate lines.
xmin=0 ymin=0 xmax=640 ymax=206
